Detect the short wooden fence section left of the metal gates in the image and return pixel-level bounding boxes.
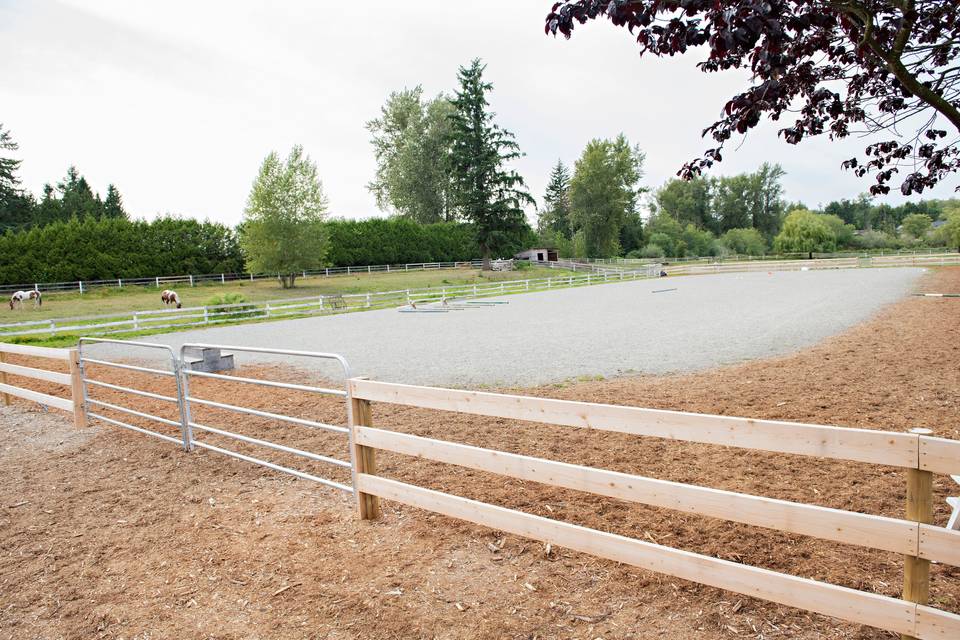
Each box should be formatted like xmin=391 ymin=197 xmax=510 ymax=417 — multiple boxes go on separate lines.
xmin=0 ymin=343 xmax=86 ymax=427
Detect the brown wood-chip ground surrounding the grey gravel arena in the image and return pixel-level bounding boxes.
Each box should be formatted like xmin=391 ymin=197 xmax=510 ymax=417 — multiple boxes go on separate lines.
xmin=0 ymin=268 xmax=960 ymax=640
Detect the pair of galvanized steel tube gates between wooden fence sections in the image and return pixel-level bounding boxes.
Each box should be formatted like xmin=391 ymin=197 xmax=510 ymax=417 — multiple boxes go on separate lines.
xmin=78 ymin=338 xmax=355 ymax=493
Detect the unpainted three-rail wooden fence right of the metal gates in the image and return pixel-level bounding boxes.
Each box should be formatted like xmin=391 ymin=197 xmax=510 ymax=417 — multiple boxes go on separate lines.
xmin=349 ymin=378 xmax=960 ymax=639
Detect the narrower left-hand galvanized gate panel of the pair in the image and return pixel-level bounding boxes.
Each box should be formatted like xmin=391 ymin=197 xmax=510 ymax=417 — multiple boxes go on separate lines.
xmin=77 ymin=338 xmax=188 ymax=448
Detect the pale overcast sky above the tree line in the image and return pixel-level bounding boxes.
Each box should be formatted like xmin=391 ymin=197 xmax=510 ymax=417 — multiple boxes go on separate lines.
xmin=0 ymin=0 xmax=957 ymax=225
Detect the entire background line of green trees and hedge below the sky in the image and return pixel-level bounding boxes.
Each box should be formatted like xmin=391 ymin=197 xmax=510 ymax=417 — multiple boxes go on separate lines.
xmin=0 ymin=45 xmax=956 ymax=286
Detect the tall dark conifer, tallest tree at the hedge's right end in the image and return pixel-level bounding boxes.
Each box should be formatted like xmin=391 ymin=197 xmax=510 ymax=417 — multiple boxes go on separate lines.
xmin=450 ymin=58 xmax=533 ymax=269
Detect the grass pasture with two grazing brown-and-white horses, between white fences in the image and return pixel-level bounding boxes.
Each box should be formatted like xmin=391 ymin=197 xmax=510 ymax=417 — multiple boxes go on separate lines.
xmin=0 ymin=267 xmax=573 ymax=324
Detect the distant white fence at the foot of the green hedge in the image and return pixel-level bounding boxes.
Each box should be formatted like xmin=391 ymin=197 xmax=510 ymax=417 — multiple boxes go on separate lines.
xmin=0 ymin=260 xmax=482 ymax=295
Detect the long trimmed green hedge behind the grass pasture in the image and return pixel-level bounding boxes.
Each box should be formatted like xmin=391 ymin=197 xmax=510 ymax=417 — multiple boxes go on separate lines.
xmin=0 ymin=217 xmax=536 ymax=284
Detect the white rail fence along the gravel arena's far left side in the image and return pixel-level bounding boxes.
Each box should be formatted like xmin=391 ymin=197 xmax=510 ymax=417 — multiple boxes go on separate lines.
xmin=0 ymin=265 xmax=660 ymax=338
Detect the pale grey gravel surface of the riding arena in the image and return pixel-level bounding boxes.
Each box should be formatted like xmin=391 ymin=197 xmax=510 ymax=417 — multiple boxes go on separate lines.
xmin=86 ymin=268 xmax=923 ymax=387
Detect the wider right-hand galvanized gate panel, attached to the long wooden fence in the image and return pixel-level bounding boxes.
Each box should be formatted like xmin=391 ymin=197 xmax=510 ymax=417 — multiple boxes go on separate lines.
xmin=180 ymin=343 xmax=354 ymax=493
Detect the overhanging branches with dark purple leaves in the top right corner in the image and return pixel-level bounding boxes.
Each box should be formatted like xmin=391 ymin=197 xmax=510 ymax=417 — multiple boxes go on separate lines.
xmin=545 ymin=0 xmax=960 ymax=195
